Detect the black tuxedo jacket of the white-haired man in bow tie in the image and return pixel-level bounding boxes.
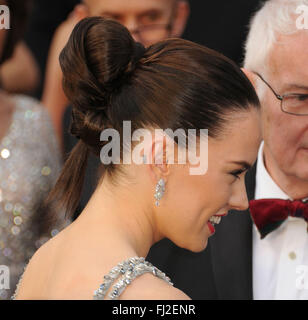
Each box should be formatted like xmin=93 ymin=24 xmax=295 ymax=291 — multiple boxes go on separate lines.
xmin=147 ymin=164 xmax=256 ymax=300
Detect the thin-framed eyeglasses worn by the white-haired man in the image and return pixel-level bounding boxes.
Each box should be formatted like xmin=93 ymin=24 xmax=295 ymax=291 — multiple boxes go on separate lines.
xmin=254 ymin=72 xmax=308 ymax=116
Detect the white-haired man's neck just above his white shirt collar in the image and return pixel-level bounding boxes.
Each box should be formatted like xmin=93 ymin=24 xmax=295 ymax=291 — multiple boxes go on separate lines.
xmin=263 ymin=145 xmax=308 ymax=200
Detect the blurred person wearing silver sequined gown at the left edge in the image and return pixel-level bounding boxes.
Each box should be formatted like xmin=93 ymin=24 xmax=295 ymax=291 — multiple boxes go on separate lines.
xmin=0 ymin=0 xmax=68 ymax=299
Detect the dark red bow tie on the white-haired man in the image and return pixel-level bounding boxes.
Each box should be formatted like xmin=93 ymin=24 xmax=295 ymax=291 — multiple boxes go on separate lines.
xmin=249 ymin=199 xmax=308 ymax=239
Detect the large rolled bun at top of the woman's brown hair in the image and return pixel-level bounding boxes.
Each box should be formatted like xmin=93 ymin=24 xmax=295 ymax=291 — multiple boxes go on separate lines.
xmin=60 ymin=17 xmax=146 ymax=116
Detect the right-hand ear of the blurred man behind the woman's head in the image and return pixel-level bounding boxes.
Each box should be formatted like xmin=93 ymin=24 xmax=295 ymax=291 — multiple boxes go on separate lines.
xmin=171 ymin=0 xmax=190 ymax=38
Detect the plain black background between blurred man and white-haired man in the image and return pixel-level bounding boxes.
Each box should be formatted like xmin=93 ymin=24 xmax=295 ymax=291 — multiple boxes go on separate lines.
xmin=184 ymin=0 xmax=264 ymax=64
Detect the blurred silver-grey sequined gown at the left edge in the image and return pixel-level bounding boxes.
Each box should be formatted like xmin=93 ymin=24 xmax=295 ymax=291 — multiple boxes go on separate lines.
xmin=0 ymin=95 xmax=64 ymax=300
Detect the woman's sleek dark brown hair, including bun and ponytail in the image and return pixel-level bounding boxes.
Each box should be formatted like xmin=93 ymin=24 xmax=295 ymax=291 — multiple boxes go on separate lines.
xmin=44 ymin=17 xmax=259 ymax=225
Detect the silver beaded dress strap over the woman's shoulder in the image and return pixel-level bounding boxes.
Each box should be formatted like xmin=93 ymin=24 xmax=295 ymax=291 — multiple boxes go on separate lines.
xmin=93 ymin=257 xmax=173 ymax=300
